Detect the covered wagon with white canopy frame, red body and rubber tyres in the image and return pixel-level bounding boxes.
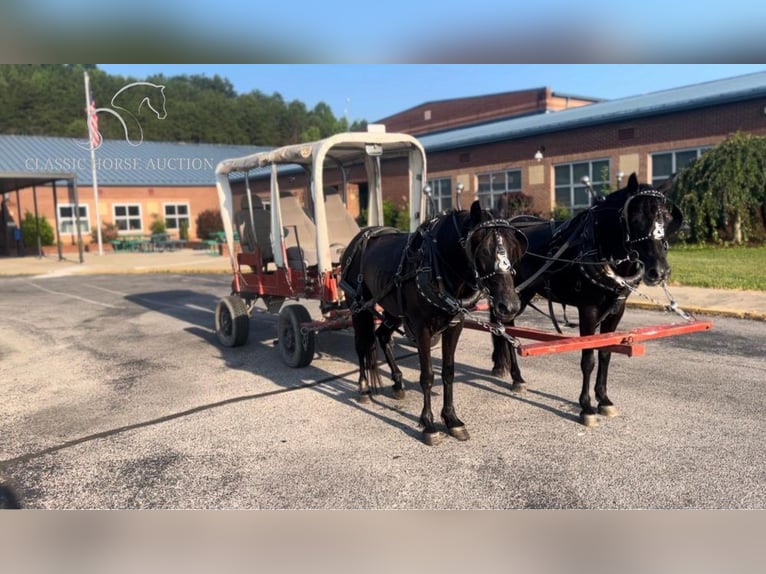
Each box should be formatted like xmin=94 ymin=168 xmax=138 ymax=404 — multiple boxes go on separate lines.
xmin=215 ymin=125 xmax=426 ymax=367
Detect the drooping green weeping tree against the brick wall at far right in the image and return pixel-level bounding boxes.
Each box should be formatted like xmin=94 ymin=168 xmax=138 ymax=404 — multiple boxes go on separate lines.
xmin=671 ymin=133 xmax=766 ymax=243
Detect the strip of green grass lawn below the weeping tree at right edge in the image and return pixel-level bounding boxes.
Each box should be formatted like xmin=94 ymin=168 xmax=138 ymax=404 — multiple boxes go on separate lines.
xmin=668 ymin=245 xmax=766 ymax=291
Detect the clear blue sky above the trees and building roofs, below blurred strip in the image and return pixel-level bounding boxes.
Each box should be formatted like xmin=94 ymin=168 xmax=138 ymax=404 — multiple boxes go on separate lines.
xmin=99 ymin=64 xmax=766 ymax=121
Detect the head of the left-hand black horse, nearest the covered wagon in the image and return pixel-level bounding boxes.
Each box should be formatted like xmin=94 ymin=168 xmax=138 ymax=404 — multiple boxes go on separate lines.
xmin=465 ymin=201 xmax=527 ymax=323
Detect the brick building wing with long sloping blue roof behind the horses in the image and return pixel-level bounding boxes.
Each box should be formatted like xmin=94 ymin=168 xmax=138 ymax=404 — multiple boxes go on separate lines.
xmin=404 ymin=72 xmax=766 ymax=215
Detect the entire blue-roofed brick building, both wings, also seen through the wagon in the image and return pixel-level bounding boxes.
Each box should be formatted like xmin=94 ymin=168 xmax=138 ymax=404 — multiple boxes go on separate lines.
xmin=0 ymin=71 xmax=766 ymax=255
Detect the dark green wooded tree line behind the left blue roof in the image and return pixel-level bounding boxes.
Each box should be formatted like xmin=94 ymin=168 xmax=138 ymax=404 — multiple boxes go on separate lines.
xmin=0 ymin=64 xmax=366 ymax=146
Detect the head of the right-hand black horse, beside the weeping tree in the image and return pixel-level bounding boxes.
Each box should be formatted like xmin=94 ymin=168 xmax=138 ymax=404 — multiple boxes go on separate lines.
xmin=594 ymin=173 xmax=683 ymax=285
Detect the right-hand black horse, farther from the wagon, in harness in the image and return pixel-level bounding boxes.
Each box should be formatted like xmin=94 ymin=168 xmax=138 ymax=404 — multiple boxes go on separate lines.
xmin=490 ymin=173 xmax=682 ymax=426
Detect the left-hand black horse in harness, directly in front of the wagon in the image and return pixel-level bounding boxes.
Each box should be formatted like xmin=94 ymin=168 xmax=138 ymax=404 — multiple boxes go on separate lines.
xmin=340 ymin=201 xmax=526 ymax=444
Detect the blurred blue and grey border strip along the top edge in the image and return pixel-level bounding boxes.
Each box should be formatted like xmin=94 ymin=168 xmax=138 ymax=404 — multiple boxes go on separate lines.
xmin=6 ymin=0 xmax=766 ymax=65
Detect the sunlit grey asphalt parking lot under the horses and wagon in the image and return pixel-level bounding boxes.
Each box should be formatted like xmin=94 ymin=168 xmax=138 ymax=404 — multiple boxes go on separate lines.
xmin=0 ymin=274 xmax=766 ymax=509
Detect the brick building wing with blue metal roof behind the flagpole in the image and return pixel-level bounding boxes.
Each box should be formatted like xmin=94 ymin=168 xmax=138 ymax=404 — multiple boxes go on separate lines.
xmin=0 ymin=135 xmax=266 ymax=254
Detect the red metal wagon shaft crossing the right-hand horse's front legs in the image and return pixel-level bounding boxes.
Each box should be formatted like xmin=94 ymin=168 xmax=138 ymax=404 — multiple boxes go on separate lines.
xmin=465 ymin=320 xmax=713 ymax=357
